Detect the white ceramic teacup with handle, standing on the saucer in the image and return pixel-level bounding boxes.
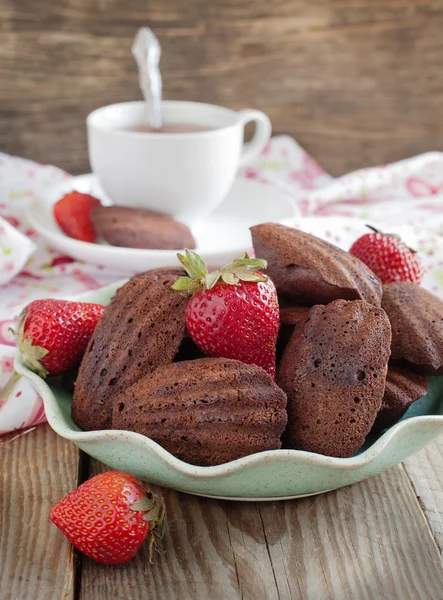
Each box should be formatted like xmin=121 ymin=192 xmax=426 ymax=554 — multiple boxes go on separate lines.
xmin=87 ymin=101 xmax=271 ymax=223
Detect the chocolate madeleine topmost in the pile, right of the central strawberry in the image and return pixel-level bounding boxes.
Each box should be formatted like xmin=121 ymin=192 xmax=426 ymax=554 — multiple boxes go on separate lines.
xmin=251 ymin=223 xmax=382 ymax=306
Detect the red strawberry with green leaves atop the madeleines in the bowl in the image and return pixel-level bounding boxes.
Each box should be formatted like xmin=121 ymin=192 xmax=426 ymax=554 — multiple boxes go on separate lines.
xmin=172 ymin=250 xmax=279 ymax=376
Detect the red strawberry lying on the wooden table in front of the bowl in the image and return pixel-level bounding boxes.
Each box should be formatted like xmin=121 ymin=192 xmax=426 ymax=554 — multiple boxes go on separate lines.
xmin=51 ymin=471 xmax=165 ymax=565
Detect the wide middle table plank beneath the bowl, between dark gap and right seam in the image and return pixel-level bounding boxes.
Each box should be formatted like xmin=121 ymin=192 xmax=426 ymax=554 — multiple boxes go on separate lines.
xmin=80 ymin=461 xmax=443 ymax=600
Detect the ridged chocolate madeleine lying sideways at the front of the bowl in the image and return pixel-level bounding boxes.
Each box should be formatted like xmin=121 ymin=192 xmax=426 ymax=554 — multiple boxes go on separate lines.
xmin=112 ymin=358 xmax=287 ymax=466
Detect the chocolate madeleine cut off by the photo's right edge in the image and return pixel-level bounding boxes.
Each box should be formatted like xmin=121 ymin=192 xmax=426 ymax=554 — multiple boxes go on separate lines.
xmin=382 ymin=281 xmax=443 ymax=375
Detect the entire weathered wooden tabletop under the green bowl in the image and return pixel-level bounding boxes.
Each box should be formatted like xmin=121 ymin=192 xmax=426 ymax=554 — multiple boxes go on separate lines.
xmin=0 ymin=425 xmax=443 ymax=600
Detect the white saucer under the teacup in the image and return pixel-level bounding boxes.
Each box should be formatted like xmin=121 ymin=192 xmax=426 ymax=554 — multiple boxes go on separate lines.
xmin=28 ymin=174 xmax=298 ymax=272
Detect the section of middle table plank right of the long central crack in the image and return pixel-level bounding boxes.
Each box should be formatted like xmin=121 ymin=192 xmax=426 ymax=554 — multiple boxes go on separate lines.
xmin=260 ymin=466 xmax=443 ymax=600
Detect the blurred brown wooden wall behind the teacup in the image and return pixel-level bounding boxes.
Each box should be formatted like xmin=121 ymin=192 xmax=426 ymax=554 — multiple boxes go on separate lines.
xmin=0 ymin=0 xmax=443 ymax=175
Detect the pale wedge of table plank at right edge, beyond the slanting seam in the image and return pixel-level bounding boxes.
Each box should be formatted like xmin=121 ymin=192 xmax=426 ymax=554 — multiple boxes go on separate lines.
xmin=404 ymin=436 xmax=443 ymax=556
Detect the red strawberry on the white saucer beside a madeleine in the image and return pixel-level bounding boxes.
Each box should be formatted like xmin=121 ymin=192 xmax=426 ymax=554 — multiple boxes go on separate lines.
xmin=54 ymin=191 xmax=101 ymax=242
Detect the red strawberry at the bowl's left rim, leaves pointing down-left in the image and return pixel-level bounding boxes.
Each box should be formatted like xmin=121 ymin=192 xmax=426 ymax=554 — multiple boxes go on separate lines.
xmin=15 ymin=299 xmax=105 ymax=377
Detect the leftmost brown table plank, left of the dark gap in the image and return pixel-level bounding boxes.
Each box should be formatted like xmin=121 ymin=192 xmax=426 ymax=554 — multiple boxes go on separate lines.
xmin=0 ymin=425 xmax=78 ymax=600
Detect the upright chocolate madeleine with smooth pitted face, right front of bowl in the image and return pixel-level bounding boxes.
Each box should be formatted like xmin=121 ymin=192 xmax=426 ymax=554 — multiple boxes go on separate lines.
xmin=277 ymin=300 xmax=391 ymax=457
